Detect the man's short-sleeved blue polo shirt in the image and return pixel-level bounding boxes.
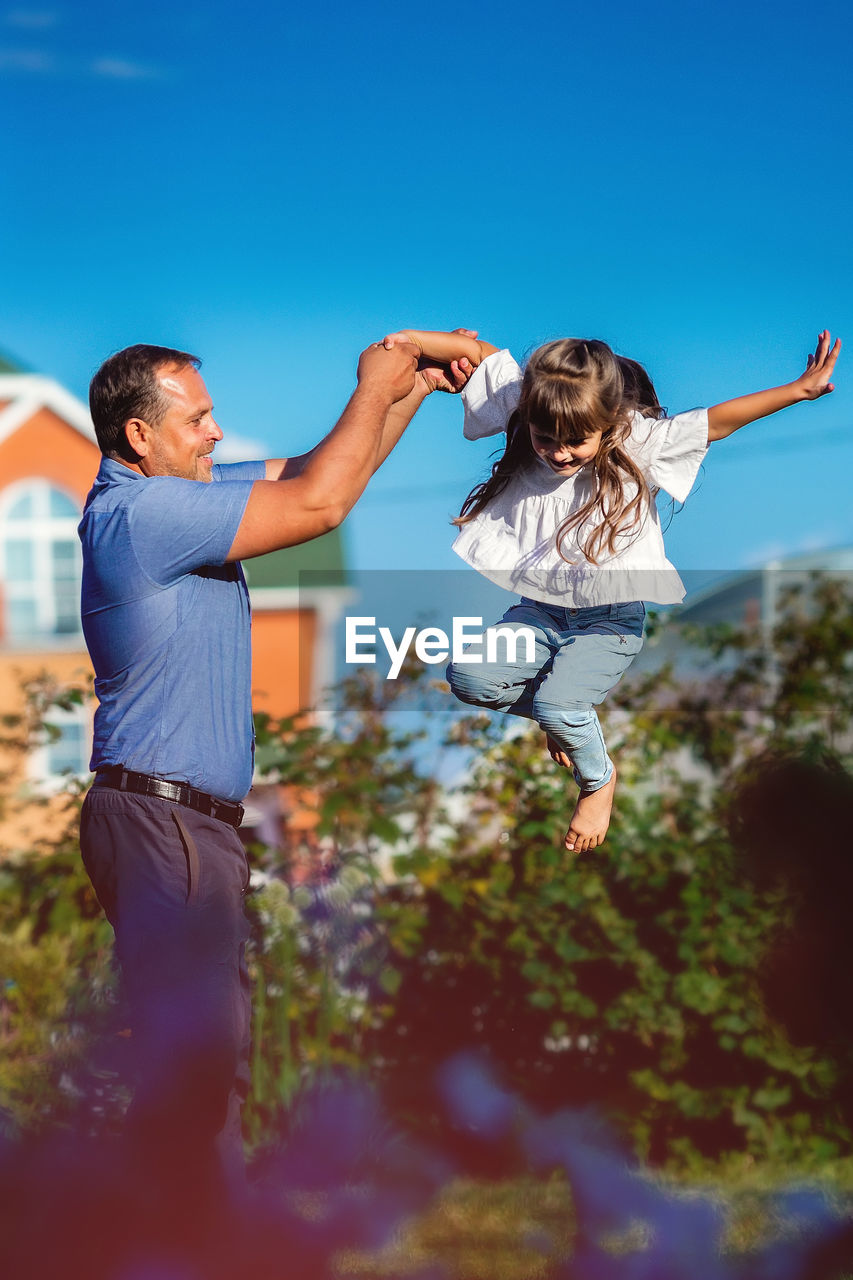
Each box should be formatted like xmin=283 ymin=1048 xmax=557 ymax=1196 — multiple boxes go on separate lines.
xmin=79 ymin=458 xmax=265 ymax=800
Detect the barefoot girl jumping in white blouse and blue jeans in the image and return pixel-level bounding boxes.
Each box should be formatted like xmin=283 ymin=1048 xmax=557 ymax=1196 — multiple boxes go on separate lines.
xmin=386 ymin=329 xmax=841 ymax=852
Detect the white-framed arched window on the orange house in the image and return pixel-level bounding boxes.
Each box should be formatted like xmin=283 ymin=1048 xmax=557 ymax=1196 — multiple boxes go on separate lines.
xmin=0 ymin=480 xmax=82 ymax=644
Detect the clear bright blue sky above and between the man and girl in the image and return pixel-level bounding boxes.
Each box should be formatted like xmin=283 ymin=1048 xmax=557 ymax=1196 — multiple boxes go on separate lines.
xmin=0 ymin=0 xmax=853 ymax=581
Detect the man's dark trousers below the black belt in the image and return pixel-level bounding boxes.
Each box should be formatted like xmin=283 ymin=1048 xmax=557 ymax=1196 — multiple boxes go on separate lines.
xmin=81 ymin=785 xmax=251 ymax=1183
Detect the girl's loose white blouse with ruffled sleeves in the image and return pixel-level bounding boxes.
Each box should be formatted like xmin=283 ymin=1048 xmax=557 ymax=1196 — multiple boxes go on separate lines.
xmin=453 ymin=351 xmax=708 ymax=608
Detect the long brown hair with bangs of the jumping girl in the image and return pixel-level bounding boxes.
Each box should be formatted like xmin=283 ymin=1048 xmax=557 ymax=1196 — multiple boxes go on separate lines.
xmin=453 ymin=338 xmax=663 ymax=564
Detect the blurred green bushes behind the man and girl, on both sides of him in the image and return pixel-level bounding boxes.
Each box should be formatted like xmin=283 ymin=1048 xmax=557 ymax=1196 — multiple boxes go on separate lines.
xmin=0 ymin=580 xmax=853 ymax=1167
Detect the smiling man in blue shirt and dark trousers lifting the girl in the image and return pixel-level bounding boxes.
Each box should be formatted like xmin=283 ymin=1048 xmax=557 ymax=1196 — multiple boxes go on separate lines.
xmin=79 ymin=343 xmax=422 ymax=1194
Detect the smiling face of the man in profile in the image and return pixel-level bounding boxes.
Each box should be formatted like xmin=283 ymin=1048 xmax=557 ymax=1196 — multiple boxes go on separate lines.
xmin=141 ymin=365 xmax=222 ymax=481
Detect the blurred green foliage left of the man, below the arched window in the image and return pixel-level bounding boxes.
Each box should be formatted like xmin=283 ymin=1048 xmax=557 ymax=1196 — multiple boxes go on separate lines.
xmin=0 ymin=672 xmax=123 ymax=1130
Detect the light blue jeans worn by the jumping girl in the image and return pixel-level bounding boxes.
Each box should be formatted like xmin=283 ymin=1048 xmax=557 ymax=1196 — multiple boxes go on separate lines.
xmin=447 ymin=596 xmax=646 ymax=791
